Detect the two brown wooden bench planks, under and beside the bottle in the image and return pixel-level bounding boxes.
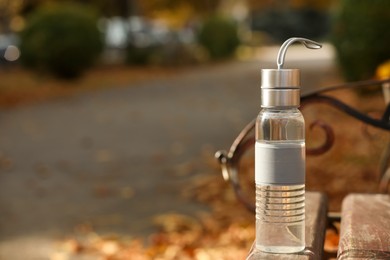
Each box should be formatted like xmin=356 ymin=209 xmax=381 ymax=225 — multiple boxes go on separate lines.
xmin=247 ymin=192 xmax=390 ymax=260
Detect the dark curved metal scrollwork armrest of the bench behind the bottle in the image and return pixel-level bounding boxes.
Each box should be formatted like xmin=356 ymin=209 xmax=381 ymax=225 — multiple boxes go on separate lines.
xmin=215 ymin=79 xmax=390 ymax=212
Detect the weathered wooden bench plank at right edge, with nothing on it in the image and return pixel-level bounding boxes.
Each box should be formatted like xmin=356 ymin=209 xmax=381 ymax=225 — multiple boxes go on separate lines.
xmin=338 ymin=194 xmax=390 ymax=259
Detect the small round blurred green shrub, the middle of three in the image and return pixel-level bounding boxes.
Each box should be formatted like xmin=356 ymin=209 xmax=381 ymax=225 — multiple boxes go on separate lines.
xmin=198 ymin=16 xmax=240 ymax=59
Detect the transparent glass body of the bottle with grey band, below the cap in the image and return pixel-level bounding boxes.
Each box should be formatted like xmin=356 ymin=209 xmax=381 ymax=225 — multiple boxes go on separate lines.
xmin=255 ymin=108 xmax=305 ymax=253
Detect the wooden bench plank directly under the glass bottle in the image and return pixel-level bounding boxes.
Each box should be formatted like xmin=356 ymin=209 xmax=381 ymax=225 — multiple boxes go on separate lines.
xmin=247 ymin=192 xmax=328 ymax=260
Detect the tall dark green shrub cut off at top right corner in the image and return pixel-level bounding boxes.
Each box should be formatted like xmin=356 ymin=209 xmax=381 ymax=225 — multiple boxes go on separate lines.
xmin=331 ymin=0 xmax=390 ymax=81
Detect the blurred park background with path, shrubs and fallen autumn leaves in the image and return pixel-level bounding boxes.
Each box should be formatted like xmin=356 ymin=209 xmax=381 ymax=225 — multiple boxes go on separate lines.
xmin=0 ymin=0 xmax=390 ymax=260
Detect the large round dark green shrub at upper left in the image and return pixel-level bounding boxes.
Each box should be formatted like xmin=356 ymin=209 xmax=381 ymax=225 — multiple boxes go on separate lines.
xmin=20 ymin=4 xmax=103 ymax=78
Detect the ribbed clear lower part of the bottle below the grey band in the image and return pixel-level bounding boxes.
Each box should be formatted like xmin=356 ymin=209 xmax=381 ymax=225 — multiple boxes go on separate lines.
xmin=256 ymin=185 xmax=305 ymax=253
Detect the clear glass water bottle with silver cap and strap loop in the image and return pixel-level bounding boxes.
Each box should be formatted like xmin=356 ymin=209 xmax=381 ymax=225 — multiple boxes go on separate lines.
xmin=255 ymin=38 xmax=321 ymax=253
